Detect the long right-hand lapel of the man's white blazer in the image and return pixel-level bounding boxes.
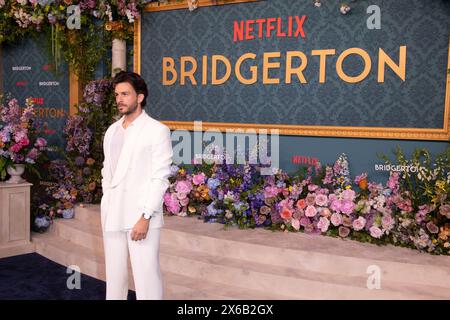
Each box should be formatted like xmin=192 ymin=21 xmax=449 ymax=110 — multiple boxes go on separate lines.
xmin=110 ymin=111 xmax=146 ymax=187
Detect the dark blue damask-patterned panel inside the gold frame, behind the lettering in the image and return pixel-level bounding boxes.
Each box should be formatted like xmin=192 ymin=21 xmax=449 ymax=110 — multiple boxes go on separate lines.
xmin=141 ymin=0 xmax=450 ymax=128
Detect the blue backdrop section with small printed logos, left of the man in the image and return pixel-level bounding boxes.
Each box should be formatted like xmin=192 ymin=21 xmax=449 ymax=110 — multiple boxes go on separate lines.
xmin=2 ymin=39 xmax=69 ymax=157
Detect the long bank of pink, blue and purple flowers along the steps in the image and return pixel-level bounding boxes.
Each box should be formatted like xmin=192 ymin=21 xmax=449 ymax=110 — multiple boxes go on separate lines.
xmin=164 ymin=148 xmax=450 ymax=255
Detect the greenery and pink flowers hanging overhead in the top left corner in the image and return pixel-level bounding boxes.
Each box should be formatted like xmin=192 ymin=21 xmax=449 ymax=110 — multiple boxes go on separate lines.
xmin=0 ymin=0 xmax=143 ymax=83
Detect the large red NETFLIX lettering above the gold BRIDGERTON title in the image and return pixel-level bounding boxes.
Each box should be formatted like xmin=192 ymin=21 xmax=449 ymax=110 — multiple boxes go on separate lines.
xmin=233 ymin=15 xmax=306 ymax=42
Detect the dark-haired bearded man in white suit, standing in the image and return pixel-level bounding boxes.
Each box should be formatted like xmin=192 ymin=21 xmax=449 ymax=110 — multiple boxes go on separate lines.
xmin=100 ymin=71 xmax=173 ymax=300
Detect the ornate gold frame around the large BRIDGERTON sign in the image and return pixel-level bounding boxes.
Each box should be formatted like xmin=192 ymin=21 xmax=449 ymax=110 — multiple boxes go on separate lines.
xmin=134 ymin=0 xmax=450 ymax=141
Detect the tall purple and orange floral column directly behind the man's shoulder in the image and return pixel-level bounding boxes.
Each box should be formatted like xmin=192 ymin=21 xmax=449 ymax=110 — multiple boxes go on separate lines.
xmin=40 ymin=79 xmax=116 ymax=217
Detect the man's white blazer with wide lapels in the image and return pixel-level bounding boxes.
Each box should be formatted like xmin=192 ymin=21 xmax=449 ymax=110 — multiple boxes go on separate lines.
xmin=100 ymin=110 xmax=173 ymax=231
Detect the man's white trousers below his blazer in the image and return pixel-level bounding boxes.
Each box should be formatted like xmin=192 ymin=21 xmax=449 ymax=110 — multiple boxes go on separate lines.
xmin=103 ymin=228 xmax=163 ymax=300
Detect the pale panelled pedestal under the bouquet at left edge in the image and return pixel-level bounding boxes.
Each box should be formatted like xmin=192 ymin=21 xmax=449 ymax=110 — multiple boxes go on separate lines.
xmin=0 ymin=182 xmax=35 ymax=258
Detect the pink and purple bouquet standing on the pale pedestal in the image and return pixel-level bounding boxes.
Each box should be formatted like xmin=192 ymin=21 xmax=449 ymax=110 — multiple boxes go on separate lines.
xmin=0 ymin=96 xmax=47 ymax=180
